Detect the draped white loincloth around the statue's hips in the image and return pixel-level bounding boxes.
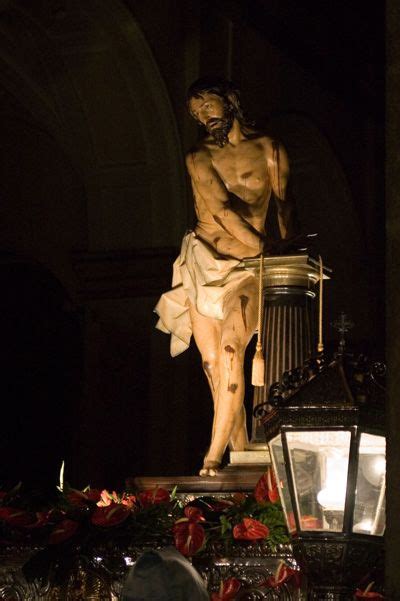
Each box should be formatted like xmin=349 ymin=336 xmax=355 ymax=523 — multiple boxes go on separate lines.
xmin=154 ymin=232 xmax=254 ymax=357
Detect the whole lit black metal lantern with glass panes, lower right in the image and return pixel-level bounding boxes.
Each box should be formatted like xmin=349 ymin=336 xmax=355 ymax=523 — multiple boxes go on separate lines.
xmin=263 ymin=354 xmax=386 ymax=600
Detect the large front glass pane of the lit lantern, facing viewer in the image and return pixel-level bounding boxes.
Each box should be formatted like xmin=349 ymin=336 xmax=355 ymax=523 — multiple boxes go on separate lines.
xmin=286 ymin=430 xmax=351 ymax=532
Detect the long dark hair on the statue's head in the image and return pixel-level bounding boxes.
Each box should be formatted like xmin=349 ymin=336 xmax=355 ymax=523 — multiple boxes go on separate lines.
xmin=186 ymin=76 xmax=254 ymax=126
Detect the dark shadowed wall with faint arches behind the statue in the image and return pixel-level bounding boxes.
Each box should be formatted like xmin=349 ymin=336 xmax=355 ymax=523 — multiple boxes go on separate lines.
xmin=0 ymin=0 xmax=385 ymax=487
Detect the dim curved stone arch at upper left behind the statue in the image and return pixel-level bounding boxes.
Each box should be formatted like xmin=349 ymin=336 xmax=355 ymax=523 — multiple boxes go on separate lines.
xmin=0 ymin=0 xmax=186 ymax=268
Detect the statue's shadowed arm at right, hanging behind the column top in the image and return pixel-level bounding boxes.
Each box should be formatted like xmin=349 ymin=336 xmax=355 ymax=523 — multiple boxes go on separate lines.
xmin=267 ymin=139 xmax=296 ymax=239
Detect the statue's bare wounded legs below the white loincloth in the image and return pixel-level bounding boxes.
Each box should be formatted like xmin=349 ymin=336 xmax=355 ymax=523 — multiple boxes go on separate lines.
xmin=191 ymin=280 xmax=257 ymax=476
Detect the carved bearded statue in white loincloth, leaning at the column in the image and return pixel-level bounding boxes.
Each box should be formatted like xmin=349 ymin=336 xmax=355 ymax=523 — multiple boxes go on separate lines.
xmin=156 ymin=78 xmax=294 ymax=476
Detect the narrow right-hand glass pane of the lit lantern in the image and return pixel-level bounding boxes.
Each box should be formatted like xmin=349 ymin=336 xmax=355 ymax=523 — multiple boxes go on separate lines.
xmin=353 ymin=432 xmax=386 ymax=536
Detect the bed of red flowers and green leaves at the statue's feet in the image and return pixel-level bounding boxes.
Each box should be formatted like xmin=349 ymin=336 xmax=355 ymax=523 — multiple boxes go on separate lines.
xmin=0 ymin=469 xmax=289 ymax=599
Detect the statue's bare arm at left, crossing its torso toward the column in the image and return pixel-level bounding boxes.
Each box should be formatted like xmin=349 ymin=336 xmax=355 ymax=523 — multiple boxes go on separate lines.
xmin=186 ymin=150 xmax=264 ymax=254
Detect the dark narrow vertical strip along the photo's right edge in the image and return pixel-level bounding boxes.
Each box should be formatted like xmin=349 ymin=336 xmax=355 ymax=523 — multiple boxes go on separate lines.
xmin=386 ymin=0 xmax=400 ymax=599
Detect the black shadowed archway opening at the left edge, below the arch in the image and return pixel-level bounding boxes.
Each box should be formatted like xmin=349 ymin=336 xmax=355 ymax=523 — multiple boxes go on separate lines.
xmin=0 ymin=254 xmax=83 ymax=489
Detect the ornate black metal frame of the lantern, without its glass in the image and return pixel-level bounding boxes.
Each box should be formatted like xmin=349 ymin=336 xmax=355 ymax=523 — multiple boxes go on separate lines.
xmin=256 ymin=354 xmax=385 ymax=601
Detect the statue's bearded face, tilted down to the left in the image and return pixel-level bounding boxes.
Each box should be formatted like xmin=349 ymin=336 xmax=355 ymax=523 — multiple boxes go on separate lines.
xmin=189 ymin=92 xmax=234 ymax=148
